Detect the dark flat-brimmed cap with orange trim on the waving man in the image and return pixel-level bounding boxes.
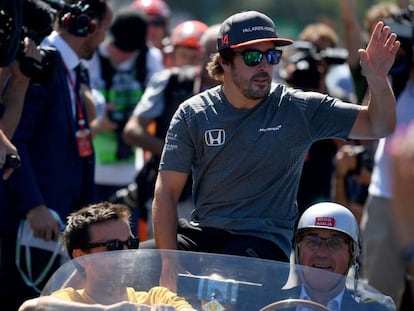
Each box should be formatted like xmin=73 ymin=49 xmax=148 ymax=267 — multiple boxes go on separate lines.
xmin=217 ymin=11 xmax=293 ymax=51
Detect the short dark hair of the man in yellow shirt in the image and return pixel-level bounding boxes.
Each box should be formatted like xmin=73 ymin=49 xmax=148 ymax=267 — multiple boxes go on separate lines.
xmin=62 ymin=202 xmax=131 ymax=258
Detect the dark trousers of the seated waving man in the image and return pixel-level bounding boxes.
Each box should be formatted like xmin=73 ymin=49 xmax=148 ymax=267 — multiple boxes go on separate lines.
xmin=140 ymin=218 xmax=289 ymax=262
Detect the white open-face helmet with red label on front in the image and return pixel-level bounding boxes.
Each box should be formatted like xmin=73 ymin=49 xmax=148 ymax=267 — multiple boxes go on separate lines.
xmin=296 ymin=202 xmax=360 ymax=260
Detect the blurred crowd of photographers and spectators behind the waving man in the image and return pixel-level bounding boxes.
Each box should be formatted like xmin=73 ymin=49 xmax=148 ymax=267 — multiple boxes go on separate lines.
xmin=0 ymin=0 xmax=414 ymax=310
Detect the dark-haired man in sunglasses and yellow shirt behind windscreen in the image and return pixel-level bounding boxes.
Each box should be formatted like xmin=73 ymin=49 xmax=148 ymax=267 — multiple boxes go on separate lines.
xmin=19 ymin=202 xmax=193 ymax=311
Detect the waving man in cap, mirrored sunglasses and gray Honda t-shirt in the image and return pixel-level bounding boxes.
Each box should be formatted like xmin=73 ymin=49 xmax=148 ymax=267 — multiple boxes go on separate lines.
xmin=147 ymin=11 xmax=400 ymax=292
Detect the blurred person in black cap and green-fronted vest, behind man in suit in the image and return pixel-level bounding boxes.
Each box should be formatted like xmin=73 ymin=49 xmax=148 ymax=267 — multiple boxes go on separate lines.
xmin=87 ymin=8 xmax=163 ymax=208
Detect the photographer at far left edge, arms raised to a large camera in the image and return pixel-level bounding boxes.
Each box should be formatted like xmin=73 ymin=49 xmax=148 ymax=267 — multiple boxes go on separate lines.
xmin=0 ymin=0 xmax=51 ymax=180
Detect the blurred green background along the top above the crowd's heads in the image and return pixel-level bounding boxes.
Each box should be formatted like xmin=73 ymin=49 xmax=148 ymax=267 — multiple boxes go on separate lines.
xmin=112 ymin=0 xmax=396 ymax=45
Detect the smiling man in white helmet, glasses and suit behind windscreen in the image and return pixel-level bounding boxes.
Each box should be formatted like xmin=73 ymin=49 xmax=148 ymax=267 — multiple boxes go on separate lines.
xmin=288 ymin=202 xmax=395 ymax=310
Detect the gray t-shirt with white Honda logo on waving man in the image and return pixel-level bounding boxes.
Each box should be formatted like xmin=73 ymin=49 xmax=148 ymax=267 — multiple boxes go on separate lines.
xmin=160 ymin=84 xmax=360 ymax=256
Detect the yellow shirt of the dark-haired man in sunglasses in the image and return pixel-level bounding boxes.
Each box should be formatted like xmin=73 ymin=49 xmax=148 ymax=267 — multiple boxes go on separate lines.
xmin=52 ymin=286 xmax=191 ymax=310
